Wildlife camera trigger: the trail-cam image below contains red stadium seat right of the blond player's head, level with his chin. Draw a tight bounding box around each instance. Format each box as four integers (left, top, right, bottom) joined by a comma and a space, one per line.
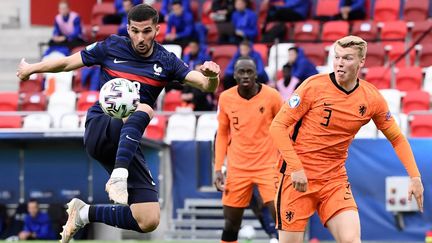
396, 67, 423, 91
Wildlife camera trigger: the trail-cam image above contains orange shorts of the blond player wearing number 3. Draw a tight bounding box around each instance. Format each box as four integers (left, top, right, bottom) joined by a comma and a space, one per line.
275, 175, 357, 232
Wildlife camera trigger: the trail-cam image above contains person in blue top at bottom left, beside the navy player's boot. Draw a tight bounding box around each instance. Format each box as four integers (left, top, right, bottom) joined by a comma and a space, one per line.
18, 199, 56, 240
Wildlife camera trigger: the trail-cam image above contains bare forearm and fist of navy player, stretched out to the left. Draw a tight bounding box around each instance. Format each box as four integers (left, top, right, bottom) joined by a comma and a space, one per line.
16, 52, 84, 80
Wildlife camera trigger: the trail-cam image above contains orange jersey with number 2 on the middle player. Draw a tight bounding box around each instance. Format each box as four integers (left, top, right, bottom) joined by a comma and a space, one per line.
215, 84, 283, 171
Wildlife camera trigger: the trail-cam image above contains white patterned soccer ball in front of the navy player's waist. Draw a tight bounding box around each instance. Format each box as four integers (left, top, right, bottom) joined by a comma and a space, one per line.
99, 78, 140, 119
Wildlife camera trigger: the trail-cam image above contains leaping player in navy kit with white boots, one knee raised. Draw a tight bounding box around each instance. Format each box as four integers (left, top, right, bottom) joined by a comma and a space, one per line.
17, 4, 220, 243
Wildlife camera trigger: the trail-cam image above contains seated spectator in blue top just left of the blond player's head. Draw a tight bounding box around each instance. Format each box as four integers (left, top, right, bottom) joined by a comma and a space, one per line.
287, 47, 318, 91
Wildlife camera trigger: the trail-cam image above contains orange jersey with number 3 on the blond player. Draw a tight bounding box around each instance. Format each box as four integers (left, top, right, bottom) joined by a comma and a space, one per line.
272, 73, 395, 179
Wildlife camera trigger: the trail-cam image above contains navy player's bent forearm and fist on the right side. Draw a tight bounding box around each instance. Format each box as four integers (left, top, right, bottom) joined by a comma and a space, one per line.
185, 61, 220, 92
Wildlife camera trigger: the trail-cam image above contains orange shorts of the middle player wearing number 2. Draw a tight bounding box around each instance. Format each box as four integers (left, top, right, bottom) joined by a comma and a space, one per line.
222, 168, 277, 208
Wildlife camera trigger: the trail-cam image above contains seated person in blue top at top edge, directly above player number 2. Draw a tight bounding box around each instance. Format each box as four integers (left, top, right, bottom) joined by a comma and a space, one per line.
218, 0, 258, 44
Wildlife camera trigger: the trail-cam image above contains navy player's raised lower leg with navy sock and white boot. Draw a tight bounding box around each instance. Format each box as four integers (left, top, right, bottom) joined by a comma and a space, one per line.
105, 104, 154, 205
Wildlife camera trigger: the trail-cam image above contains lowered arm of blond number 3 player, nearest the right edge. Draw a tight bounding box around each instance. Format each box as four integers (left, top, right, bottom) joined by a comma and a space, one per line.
382, 122, 424, 212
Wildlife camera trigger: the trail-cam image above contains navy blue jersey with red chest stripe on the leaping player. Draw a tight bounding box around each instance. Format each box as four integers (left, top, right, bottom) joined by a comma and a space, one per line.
81, 35, 190, 106
